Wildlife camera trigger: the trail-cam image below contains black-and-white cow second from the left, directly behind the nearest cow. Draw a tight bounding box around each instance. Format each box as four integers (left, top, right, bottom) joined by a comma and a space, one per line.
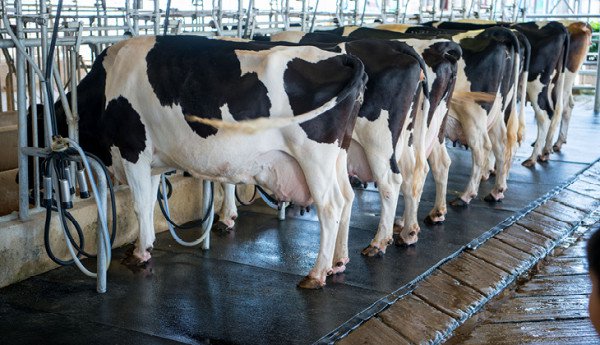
218, 33, 438, 251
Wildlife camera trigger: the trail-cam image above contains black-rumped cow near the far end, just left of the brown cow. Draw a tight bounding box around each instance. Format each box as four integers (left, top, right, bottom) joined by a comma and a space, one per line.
420, 21, 568, 167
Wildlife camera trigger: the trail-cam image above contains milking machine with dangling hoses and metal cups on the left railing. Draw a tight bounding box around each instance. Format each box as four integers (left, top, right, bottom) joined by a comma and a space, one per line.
11, 0, 116, 292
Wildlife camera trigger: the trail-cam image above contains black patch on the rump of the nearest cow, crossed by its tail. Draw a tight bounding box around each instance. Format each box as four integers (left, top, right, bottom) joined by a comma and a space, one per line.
283, 55, 363, 147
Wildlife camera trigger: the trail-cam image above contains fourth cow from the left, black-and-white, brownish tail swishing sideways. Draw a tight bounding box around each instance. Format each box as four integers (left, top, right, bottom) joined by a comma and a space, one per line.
322, 27, 520, 210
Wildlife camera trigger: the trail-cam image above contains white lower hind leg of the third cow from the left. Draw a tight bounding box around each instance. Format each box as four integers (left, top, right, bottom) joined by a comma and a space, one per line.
425, 142, 451, 224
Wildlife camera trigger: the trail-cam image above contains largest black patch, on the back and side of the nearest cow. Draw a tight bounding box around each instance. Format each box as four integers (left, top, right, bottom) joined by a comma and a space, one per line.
146, 35, 271, 138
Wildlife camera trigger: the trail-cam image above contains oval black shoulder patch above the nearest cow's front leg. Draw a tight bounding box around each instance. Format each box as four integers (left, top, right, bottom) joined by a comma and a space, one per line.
102, 96, 146, 163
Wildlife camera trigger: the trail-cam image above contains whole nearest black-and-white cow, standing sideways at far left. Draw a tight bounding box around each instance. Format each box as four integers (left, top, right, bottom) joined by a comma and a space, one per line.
45, 36, 366, 288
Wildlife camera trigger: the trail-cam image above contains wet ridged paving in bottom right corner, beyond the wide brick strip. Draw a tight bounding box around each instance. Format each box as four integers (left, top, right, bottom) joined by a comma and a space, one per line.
447, 219, 600, 345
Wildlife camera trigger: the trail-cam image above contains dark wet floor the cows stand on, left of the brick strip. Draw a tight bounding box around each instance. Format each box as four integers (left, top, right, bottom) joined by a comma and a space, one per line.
0, 98, 600, 344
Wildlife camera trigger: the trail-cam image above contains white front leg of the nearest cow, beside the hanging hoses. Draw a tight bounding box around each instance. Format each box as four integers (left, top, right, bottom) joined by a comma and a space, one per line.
123, 159, 160, 265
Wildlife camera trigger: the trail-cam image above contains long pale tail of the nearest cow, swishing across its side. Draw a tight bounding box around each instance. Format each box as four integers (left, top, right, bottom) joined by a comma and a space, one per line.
185, 55, 367, 134
